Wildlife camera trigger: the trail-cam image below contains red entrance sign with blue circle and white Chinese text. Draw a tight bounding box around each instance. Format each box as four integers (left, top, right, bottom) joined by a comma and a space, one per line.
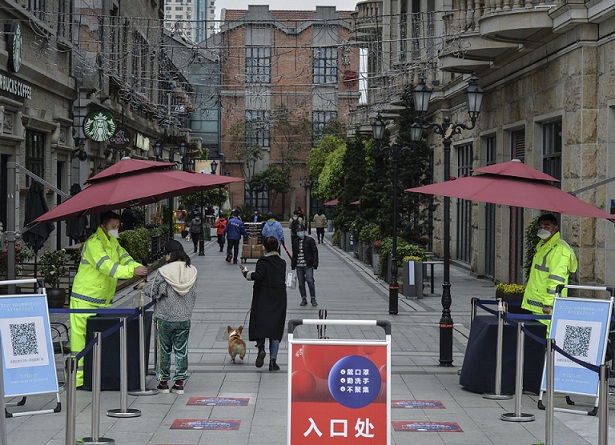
289, 344, 389, 445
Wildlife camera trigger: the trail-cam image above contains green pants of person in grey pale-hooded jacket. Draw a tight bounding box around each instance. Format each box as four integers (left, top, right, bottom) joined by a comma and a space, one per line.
156, 319, 190, 382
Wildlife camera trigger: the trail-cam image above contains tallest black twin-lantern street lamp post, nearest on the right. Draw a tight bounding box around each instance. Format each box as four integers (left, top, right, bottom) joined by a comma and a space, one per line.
410, 75, 484, 366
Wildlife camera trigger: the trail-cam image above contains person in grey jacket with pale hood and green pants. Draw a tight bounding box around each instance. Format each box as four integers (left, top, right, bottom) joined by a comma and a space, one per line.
138, 239, 197, 394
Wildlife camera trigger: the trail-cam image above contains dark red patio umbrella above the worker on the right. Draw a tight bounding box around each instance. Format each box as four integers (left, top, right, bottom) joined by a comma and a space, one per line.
405, 161, 615, 219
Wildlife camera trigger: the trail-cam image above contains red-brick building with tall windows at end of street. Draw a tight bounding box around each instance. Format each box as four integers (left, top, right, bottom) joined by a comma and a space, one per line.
220, 5, 359, 216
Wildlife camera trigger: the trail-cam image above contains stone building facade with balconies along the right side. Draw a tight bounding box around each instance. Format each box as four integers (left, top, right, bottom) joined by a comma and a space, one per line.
355, 0, 615, 284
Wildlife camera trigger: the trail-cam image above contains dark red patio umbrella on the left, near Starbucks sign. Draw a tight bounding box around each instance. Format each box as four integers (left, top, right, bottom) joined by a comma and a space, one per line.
33, 161, 243, 223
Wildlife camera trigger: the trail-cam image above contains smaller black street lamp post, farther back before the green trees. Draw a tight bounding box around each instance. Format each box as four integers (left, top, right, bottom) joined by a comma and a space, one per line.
372, 114, 407, 315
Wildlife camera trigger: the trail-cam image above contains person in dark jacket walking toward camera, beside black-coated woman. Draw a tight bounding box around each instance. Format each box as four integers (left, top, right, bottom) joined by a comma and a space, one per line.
291, 225, 318, 306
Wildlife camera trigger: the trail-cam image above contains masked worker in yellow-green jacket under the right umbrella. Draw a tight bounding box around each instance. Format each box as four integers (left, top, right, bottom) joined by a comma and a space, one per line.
521, 214, 578, 336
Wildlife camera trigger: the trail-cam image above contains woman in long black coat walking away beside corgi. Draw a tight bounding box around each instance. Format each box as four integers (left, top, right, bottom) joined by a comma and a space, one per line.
240, 237, 287, 371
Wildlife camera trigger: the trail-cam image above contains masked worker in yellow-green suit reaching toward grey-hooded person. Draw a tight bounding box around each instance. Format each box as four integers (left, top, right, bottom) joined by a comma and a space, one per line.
70, 212, 147, 387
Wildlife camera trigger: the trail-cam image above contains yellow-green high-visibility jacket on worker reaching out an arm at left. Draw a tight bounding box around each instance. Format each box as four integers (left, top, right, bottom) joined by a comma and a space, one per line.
70, 227, 141, 306
